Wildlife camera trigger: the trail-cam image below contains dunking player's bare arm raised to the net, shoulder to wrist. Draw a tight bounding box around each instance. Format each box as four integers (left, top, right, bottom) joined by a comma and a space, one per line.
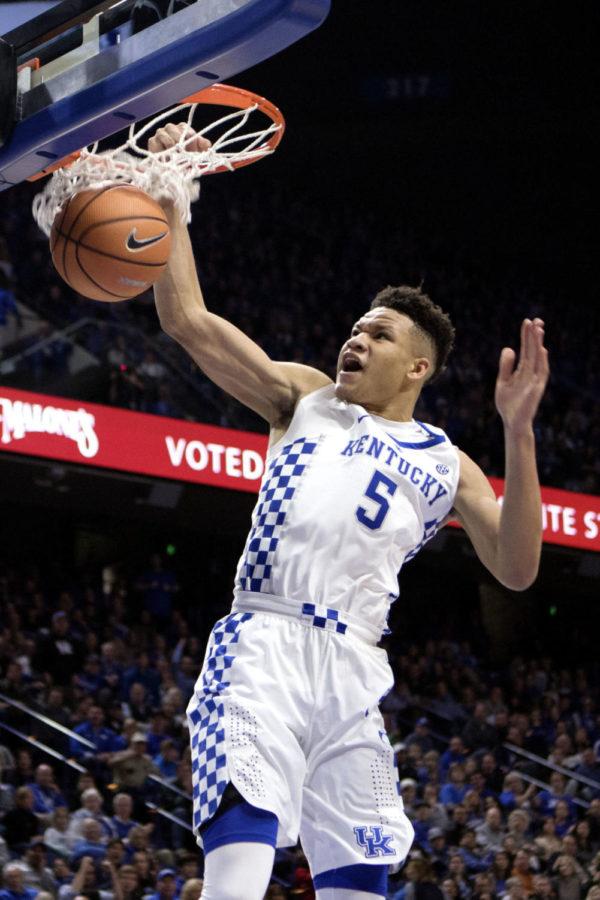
154, 199, 329, 426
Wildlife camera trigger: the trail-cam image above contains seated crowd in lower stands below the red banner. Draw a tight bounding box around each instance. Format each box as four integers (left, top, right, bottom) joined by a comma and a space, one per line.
0, 555, 600, 900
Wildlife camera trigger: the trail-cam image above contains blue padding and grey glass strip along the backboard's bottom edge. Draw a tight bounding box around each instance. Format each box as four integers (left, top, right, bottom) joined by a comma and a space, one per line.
0, 0, 330, 190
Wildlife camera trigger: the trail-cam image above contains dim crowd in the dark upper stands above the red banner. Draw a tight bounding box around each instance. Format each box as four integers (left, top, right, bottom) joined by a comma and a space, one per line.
0, 183, 600, 493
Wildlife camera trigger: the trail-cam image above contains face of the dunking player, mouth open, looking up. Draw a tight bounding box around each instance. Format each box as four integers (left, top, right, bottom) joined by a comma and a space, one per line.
335, 306, 431, 414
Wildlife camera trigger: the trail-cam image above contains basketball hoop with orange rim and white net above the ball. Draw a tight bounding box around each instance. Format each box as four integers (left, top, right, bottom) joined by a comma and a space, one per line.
31, 84, 285, 235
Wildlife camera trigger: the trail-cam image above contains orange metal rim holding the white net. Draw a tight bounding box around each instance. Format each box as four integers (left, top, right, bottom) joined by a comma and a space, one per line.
27, 82, 285, 181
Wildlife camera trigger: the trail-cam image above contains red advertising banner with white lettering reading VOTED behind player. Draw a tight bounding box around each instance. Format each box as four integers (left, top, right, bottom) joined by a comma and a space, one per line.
0, 387, 600, 551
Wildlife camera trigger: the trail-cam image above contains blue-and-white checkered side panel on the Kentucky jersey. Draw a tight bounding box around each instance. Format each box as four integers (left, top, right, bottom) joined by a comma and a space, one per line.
238, 438, 317, 594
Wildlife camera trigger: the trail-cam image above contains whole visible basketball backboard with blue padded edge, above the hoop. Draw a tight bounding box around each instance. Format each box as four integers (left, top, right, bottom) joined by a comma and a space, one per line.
0, 0, 330, 190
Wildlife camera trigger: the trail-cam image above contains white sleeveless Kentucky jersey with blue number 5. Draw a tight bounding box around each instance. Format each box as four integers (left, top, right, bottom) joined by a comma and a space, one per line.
235, 385, 459, 631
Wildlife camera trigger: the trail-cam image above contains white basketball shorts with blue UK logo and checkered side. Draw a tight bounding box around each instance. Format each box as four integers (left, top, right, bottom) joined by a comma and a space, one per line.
187, 595, 414, 876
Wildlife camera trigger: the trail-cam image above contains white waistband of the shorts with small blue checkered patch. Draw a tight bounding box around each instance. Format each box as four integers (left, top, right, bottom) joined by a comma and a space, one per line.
232, 591, 381, 644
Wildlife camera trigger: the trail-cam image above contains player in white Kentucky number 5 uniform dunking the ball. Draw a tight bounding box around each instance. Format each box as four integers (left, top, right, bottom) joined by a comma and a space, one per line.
149, 124, 548, 900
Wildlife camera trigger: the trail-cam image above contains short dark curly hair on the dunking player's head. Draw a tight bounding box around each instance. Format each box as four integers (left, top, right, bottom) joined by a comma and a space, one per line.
371, 284, 455, 382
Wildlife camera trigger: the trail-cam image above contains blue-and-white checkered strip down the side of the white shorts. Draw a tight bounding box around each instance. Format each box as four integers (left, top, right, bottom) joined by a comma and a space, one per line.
188, 613, 252, 829
